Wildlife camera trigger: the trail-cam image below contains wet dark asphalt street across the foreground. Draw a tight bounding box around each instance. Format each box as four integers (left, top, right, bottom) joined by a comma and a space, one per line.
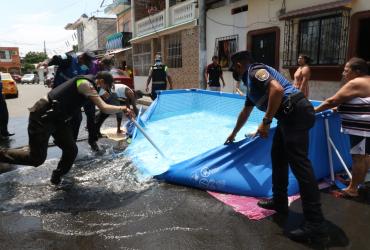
0, 114, 370, 249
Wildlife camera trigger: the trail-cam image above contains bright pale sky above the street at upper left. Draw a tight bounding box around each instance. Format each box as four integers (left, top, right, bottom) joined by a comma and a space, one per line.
0, 0, 114, 56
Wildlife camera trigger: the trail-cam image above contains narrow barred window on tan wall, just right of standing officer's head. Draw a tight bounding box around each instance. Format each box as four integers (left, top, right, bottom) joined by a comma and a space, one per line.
166, 32, 182, 68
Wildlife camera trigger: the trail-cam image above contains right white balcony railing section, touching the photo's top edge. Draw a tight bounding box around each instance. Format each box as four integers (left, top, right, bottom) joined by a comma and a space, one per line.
170, 0, 196, 25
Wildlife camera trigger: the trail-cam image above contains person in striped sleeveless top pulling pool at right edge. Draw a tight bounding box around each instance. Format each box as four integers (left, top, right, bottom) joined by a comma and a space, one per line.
315, 57, 370, 197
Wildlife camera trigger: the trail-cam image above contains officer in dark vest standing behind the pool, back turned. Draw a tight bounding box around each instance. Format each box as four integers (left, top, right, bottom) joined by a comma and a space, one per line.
146, 54, 172, 100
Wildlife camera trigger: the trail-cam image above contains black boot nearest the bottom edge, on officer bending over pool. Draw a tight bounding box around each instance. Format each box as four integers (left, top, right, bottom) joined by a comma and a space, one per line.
288, 221, 329, 244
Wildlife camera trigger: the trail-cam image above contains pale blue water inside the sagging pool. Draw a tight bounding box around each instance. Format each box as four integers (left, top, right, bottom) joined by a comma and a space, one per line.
127, 111, 260, 175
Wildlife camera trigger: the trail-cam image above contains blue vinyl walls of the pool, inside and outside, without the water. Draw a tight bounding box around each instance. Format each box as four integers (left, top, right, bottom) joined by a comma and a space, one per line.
130, 89, 351, 197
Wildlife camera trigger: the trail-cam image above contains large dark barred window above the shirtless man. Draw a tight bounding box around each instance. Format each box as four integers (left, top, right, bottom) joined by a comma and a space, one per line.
283, 11, 349, 66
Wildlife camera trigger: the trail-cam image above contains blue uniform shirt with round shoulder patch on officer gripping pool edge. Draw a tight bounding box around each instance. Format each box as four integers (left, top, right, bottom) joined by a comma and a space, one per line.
242, 63, 299, 111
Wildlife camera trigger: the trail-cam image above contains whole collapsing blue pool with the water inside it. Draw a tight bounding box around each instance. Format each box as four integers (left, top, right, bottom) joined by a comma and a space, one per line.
127, 89, 351, 197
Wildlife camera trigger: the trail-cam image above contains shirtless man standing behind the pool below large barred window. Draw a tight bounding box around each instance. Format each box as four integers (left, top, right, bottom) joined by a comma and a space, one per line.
293, 54, 311, 98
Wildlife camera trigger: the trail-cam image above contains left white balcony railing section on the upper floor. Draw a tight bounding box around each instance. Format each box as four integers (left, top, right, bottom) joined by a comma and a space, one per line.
136, 11, 165, 36
